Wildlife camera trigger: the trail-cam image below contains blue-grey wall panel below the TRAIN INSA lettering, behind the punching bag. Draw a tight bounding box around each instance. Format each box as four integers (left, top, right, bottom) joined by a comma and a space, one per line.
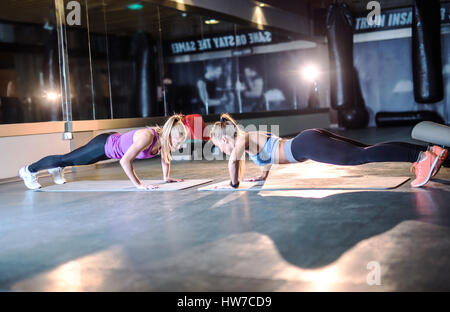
354, 34, 450, 126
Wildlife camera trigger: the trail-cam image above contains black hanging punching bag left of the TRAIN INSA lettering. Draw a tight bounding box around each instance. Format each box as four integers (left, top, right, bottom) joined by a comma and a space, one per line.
326, 3, 353, 109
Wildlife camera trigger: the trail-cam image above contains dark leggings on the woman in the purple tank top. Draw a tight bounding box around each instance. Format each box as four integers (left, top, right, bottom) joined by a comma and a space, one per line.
28, 133, 113, 172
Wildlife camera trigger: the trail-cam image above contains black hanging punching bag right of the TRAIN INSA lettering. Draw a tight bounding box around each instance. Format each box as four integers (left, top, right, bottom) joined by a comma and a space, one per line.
411, 0, 444, 103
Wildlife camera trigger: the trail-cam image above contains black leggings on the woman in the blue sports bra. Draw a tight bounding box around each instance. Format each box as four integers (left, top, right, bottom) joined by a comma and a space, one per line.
291, 129, 427, 165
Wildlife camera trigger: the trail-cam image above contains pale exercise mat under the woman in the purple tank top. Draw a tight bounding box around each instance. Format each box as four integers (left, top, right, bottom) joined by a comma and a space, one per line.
37, 179, 212, 192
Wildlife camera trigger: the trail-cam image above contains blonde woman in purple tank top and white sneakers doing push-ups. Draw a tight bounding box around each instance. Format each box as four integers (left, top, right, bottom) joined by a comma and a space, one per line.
19, 115, 188, 189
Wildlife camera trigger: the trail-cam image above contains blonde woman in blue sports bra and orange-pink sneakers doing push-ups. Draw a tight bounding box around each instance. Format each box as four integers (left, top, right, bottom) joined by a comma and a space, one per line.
210, 114, 450, 188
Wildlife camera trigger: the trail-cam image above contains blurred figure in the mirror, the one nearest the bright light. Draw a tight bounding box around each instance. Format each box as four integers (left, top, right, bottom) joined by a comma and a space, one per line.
236, 64, 264, 112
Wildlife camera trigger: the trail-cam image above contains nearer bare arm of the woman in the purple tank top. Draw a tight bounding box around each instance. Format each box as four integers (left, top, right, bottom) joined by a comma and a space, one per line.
120, 131, 155, 189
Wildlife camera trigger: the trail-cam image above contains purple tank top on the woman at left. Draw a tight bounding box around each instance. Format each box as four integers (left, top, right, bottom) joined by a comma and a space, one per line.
105, 128, 158, 159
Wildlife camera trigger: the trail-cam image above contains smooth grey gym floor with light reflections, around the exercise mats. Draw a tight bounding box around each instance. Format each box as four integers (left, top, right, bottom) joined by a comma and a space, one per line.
0, 128, 450, 291
